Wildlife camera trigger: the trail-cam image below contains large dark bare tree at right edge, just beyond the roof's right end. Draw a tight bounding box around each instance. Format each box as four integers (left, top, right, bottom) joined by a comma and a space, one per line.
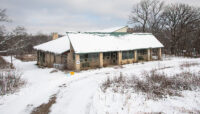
162, 4, 200, 54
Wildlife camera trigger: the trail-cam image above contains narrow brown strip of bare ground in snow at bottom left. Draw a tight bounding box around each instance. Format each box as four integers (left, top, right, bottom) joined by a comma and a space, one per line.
31, 95, 57, 114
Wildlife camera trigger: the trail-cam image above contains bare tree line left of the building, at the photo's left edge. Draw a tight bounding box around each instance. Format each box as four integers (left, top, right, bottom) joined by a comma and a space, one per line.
0, 9, 52, 55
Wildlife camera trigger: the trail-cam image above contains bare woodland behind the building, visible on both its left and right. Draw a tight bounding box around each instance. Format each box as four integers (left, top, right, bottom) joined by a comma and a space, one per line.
0, 0, 200, 55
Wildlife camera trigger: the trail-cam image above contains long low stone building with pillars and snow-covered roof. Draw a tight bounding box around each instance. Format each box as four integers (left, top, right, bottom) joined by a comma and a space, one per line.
34, 32, 164, 71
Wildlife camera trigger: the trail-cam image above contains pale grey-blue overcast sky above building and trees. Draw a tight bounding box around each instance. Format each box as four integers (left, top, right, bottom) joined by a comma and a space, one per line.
0, 0, 200, 33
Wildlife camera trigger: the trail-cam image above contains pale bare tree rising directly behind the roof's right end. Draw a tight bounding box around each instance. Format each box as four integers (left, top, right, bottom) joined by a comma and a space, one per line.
129, 0, 164, 32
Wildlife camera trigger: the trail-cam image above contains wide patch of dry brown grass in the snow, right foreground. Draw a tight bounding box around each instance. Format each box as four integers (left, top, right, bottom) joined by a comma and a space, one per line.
101, 70, 200, 99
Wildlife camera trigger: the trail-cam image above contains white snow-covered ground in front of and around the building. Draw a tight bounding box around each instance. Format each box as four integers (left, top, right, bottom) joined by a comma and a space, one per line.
0, 57, 200, 114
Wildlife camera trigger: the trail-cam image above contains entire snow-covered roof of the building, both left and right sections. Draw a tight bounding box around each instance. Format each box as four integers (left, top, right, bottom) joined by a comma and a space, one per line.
34, 32, 164, 54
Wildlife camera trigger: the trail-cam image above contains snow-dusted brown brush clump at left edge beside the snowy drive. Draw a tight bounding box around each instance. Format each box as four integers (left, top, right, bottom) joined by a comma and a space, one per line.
0, 69, 25, 95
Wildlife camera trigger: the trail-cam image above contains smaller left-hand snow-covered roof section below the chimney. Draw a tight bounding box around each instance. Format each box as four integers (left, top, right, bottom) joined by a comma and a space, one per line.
34, 35, 70, 54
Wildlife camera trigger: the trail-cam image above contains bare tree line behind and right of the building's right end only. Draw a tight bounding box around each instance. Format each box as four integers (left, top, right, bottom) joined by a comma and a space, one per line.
128, 0, 200, 55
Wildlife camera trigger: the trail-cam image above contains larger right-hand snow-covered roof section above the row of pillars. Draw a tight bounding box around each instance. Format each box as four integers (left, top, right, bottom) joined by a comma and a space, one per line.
68, 33, 164, 53
